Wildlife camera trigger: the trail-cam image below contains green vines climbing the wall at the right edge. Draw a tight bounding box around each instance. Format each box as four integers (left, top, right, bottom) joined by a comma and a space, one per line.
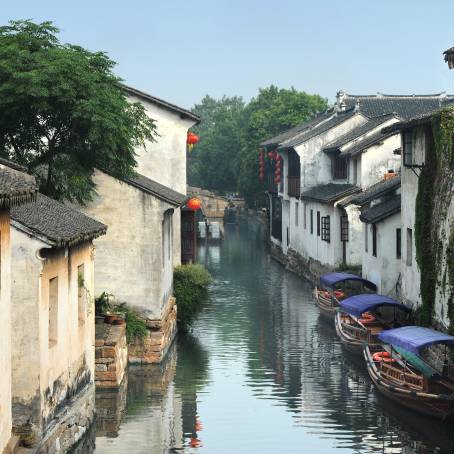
415, 107, 454, 333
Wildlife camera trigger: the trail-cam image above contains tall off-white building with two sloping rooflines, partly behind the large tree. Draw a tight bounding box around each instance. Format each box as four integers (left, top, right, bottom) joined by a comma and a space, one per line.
81, 86, 199, 363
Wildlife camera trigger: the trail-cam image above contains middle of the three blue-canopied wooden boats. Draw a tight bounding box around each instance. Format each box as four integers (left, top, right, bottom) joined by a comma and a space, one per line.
334, 293, 411, 355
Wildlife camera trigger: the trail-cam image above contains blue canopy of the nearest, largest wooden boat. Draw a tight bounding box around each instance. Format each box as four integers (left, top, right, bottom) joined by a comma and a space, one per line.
378, 326, 454, 355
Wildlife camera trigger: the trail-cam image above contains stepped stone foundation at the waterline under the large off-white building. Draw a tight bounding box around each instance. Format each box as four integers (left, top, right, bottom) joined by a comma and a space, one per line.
129, 297, 177, 364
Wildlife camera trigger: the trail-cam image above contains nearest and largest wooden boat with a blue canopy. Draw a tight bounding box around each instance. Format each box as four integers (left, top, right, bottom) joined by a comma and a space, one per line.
363, 326, 454, 419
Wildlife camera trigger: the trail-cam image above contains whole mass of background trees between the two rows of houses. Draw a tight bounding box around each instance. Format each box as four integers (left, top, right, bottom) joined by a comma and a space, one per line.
189, 85, 327, 206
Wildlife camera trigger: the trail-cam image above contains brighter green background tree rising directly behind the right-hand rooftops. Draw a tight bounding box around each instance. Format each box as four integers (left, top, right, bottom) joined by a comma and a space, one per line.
238, 85, 328, 206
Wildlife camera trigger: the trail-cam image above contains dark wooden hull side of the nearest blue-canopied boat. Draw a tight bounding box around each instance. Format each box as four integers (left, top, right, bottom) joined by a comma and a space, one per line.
363, 346, 454, 420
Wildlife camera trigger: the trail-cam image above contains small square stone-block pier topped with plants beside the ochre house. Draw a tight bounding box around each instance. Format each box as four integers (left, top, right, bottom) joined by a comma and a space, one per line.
95, 323, 128, 388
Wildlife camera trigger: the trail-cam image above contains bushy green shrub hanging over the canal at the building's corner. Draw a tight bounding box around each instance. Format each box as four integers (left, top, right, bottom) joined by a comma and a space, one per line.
173, 264, 211, 331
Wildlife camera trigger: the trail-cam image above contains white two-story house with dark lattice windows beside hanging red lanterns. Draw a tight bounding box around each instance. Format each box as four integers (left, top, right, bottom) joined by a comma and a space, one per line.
262, 92, 452, 278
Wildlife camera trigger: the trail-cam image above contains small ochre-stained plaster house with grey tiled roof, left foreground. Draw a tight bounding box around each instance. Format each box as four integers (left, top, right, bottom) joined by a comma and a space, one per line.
11, 194, 106, 452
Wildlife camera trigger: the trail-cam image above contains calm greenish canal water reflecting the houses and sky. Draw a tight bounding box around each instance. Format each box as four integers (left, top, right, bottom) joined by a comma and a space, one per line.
92, 221, 454, 454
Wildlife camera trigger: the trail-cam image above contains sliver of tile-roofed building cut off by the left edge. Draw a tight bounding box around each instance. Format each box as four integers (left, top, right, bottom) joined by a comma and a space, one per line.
0, 165, 37, 453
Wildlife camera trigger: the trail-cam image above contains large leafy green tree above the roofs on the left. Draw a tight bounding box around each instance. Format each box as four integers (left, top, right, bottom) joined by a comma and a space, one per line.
0, 20, 156, 203
